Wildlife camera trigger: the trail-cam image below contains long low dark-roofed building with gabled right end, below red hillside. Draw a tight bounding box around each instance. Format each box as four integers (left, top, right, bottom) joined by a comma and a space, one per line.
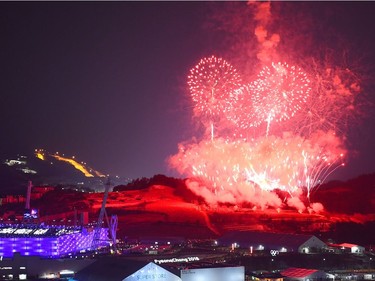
218, 231, 327, 255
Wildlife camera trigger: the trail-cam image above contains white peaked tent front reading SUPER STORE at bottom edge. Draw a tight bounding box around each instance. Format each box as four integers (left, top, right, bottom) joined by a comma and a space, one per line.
122, 262, 181, 281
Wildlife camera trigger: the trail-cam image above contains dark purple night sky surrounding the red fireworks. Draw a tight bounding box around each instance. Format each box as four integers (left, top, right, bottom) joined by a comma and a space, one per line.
0, 2, 375, 178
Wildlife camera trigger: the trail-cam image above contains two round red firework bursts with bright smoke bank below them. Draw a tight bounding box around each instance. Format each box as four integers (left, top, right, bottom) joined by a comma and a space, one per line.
170, 54, 358, 212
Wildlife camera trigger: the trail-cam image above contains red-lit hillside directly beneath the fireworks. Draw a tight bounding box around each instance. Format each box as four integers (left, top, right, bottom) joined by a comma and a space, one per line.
5, 175, 368, 244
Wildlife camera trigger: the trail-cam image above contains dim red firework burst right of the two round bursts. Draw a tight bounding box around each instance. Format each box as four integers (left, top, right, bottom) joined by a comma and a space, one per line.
285, 65, 363, 137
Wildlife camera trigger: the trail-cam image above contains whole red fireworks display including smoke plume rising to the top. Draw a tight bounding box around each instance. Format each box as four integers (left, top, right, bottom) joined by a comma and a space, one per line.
170, 2, 361, 213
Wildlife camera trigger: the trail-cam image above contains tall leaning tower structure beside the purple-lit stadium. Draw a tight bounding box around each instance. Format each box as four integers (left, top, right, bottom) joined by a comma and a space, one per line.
91, 178, 117, 252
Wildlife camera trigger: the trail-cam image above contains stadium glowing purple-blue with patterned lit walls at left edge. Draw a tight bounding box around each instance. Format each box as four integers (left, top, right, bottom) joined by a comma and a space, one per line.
0, 224, 109, 258
